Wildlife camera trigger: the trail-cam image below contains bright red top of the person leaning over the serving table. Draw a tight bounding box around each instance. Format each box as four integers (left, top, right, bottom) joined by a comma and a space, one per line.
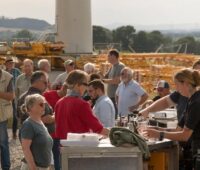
55, 96, 103, 139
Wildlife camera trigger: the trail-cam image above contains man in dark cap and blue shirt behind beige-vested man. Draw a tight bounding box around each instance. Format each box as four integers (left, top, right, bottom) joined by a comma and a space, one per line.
5, 57, 21, 139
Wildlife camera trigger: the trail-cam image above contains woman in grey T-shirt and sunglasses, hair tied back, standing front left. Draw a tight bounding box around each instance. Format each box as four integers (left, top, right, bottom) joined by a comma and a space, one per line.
20, 94, 53, 170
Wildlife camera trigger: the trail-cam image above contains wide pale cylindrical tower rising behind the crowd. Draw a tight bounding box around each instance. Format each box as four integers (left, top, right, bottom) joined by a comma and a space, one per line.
56, 0, 93, 54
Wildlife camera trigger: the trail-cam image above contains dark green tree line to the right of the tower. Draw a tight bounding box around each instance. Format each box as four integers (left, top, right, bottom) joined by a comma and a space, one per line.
93, 25, 200, 54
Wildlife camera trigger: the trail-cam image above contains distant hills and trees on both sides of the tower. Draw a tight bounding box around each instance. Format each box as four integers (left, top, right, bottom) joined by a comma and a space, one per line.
0, 17, 200, 54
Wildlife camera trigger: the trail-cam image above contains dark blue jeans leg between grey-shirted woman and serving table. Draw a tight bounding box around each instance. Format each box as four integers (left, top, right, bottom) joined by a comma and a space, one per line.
52, 139, 61, 170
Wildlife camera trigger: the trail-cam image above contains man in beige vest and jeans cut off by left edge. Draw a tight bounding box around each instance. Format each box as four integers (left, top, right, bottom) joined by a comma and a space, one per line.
0, 69, 15, 170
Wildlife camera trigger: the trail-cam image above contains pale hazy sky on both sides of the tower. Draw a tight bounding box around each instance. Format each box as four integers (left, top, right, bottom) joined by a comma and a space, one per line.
0, 0, 200, 26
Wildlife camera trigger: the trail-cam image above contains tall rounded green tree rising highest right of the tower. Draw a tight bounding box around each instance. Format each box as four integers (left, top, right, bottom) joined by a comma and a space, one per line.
113, 25, 136, 50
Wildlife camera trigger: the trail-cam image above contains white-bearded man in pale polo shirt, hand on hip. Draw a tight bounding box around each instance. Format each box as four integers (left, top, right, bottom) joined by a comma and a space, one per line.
116, 67, 148, 116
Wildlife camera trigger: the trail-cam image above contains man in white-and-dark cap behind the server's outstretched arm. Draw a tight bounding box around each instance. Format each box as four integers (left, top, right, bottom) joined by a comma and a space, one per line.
152, 80, 170, 102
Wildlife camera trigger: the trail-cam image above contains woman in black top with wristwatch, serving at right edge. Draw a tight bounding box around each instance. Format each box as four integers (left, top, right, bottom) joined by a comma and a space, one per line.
147, 69, 200, 169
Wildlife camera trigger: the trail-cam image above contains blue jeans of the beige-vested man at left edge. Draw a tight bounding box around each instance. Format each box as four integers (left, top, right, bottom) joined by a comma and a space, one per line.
0, 121, 10, 170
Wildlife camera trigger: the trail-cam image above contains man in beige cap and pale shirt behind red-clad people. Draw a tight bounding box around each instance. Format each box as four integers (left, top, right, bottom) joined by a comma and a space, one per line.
51, 59, 75, 90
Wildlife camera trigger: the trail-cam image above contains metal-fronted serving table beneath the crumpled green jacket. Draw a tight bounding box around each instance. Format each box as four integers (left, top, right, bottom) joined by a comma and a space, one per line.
61, 140, 178, 170
